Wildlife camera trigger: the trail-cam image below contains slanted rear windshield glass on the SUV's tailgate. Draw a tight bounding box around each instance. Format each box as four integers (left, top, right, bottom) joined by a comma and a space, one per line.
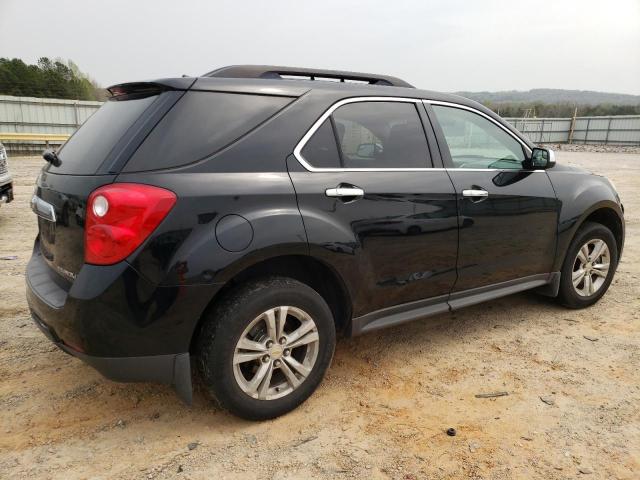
54, 95, 158, 175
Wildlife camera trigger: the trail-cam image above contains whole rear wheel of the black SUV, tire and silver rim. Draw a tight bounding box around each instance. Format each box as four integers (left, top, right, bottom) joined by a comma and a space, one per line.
197, 277, 336, 420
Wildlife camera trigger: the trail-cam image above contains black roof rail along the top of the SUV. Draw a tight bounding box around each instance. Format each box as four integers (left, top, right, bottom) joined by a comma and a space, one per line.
203, 65, 414, 88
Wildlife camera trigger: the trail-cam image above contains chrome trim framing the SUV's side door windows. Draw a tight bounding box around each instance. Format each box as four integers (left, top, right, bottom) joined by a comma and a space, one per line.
293, 97, 544, 173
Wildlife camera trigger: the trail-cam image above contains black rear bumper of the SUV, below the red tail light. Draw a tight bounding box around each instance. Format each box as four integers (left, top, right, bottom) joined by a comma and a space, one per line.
26, 241, 222, 403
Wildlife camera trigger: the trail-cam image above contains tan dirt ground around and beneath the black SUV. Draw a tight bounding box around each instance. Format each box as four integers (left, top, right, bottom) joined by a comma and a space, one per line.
0, 151, 640, 479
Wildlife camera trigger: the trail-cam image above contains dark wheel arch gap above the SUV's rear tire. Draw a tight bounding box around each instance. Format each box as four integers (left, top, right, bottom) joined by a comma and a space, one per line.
189, 254, 352, 352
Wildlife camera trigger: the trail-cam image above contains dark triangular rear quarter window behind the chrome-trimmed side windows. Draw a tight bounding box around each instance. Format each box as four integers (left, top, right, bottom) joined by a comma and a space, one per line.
124, 91, 292, 172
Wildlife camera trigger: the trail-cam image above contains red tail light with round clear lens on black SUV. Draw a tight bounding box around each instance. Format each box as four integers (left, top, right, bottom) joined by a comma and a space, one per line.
84, 183, 176, 265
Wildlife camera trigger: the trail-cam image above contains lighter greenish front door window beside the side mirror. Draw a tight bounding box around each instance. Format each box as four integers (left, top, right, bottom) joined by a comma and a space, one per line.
433, 105, 525, 169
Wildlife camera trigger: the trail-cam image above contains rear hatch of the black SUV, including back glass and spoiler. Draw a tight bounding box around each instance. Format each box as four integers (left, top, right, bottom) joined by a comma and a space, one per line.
32, 79, 193, 282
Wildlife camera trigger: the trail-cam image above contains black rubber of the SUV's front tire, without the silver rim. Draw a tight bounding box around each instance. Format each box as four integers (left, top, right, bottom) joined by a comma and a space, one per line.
558, 222, 618, 308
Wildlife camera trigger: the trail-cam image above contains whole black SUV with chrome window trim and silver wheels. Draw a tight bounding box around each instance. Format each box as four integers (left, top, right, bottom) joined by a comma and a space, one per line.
27, 66, 624, 419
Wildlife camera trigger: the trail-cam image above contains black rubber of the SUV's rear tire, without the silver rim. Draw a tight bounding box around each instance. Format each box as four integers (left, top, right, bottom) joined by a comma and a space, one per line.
198, 278, 336, 420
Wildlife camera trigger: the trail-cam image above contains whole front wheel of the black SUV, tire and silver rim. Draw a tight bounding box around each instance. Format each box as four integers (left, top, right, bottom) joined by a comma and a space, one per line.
558, 222, 618, 308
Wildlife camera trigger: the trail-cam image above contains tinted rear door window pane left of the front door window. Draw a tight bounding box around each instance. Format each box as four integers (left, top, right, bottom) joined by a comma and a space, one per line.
333, 102, 431, 168
